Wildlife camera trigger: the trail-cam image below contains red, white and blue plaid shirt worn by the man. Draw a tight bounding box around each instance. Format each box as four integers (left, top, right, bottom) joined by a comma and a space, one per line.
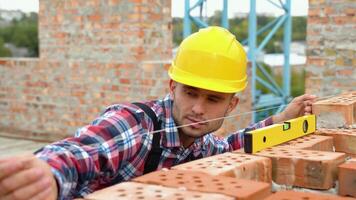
36, 95, 272, 199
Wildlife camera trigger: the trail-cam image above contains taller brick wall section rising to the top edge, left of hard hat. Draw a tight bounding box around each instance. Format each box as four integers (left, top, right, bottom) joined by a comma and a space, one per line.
39, 0, 172, 63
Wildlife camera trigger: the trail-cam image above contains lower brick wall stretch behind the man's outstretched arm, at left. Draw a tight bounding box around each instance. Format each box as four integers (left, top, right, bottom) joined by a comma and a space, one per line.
0, 59, 168, 140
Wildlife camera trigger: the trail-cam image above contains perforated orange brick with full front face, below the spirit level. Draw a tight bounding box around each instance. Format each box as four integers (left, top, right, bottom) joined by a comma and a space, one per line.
257, 147, 346, 189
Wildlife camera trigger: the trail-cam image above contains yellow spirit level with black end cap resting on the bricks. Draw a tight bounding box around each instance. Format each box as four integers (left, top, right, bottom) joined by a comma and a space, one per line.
244, 115, 316, 153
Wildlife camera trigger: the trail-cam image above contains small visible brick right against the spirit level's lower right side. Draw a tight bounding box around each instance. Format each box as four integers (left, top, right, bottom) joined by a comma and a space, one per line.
277, 134, 334, 151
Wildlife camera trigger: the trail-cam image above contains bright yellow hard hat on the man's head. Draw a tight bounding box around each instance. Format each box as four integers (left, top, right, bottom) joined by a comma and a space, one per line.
168, 26, 247, 93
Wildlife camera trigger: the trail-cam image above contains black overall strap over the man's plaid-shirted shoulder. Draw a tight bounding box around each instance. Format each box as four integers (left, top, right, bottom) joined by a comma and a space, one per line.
132, 102, 162, 174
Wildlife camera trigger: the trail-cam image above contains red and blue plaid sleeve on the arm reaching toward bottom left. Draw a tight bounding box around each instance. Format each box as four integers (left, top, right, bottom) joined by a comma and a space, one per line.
36, 109, 149, 199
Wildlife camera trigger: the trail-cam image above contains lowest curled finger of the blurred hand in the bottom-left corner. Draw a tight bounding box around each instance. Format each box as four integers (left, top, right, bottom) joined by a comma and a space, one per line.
4, 177, 51, 200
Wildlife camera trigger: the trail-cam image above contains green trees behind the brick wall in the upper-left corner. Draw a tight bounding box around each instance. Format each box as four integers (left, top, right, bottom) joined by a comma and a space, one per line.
0, 12, 38, 57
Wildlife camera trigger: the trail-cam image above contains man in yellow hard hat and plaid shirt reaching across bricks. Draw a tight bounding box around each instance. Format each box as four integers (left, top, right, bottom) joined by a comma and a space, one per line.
0, 27, 315, 200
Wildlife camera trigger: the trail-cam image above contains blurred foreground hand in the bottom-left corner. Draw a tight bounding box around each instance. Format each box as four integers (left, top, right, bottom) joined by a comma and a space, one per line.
0, 155, 58, 200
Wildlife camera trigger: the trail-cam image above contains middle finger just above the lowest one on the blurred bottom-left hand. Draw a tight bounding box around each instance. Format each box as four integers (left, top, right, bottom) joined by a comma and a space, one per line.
0, 168, 44, 196
